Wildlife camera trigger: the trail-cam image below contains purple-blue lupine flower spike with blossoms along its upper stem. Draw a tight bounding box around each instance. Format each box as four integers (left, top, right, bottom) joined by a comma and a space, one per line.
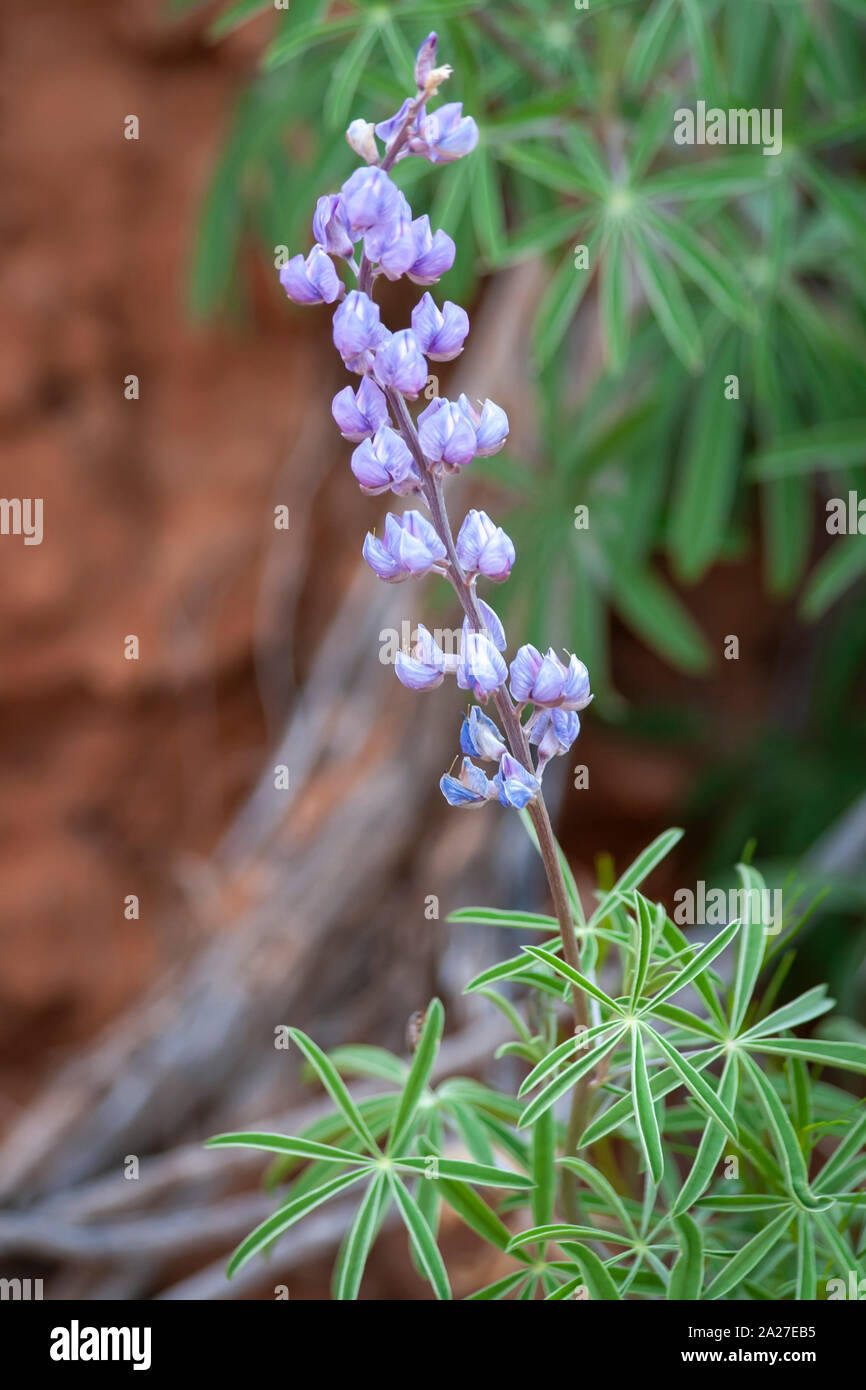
279, 33, 592, 809
